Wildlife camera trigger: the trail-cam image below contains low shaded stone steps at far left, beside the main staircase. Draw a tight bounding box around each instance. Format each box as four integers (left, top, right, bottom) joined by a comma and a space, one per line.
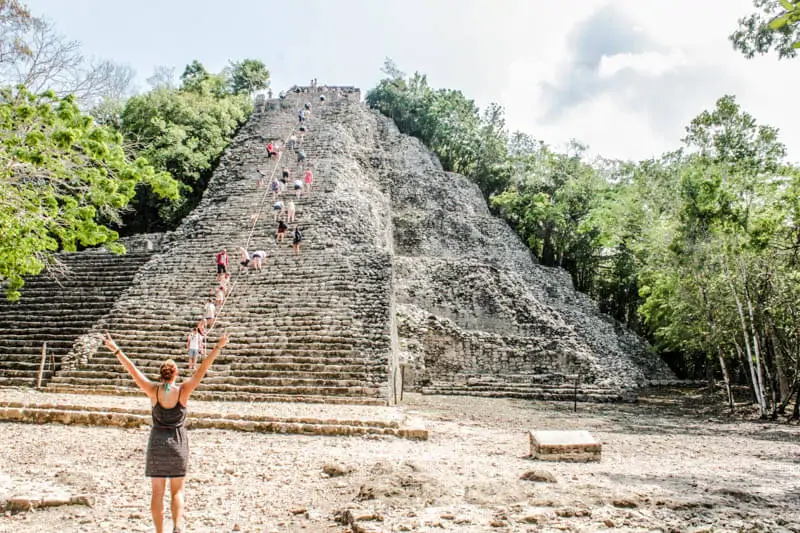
0, 251, 152, 387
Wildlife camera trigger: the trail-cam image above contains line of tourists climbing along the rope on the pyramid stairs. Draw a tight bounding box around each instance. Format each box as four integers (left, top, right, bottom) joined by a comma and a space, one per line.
186, 87, 327, 370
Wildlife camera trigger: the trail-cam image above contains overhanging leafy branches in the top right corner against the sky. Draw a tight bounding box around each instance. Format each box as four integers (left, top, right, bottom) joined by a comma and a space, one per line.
728, 0, 800, 59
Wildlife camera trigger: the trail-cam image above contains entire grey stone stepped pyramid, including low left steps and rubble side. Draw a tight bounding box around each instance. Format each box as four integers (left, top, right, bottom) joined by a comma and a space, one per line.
0, 87, 671, 405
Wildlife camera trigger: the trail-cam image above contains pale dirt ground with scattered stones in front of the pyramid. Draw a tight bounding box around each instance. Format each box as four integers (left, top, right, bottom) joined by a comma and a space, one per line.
0, 388, 800, 533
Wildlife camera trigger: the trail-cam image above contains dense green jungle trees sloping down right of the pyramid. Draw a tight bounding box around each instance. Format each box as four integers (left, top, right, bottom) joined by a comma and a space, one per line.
366, 60, 800, 416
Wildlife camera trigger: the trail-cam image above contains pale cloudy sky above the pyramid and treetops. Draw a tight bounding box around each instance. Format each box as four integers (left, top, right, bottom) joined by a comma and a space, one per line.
26, 0, 800, 161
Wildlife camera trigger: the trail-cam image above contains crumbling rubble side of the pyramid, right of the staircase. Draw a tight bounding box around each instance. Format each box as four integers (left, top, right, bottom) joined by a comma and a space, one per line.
322, 100, 670, 390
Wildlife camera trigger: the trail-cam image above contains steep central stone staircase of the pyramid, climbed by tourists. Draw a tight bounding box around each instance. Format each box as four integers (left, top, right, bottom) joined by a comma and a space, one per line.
47, 87, 391, 404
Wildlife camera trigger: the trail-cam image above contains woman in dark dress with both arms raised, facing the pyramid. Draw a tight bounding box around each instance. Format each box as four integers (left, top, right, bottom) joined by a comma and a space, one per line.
103, 332, 230, 533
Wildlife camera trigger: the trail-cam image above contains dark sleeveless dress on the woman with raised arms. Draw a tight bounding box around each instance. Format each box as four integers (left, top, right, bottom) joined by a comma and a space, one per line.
144, 385, 189, 477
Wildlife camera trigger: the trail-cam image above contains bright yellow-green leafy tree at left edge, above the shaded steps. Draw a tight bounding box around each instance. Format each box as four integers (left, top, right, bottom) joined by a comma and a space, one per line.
0, 87, 178, 299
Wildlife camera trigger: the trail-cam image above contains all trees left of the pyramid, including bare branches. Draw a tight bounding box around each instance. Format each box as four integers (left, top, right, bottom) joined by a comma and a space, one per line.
0, 0, 269, 299
